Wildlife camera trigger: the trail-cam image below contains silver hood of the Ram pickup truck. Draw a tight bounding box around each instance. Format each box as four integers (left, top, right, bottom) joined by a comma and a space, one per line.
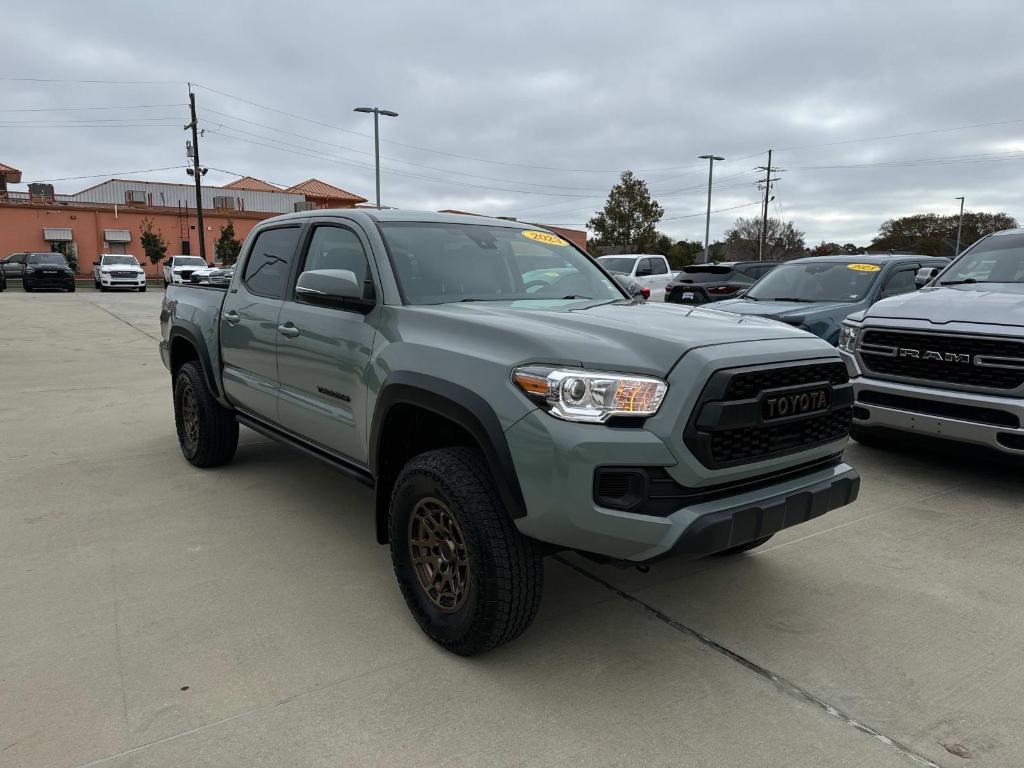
865, 283, 1024, 327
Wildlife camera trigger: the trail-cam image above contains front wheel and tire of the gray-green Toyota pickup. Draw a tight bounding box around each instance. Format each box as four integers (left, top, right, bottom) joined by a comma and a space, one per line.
390, 447, 544, 656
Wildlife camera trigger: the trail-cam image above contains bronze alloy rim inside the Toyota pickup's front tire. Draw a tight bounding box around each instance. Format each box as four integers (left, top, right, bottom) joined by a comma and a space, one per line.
409, 497, 469, 613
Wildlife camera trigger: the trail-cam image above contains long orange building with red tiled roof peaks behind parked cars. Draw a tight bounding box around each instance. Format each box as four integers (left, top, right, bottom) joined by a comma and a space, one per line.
0, 163, 587, 276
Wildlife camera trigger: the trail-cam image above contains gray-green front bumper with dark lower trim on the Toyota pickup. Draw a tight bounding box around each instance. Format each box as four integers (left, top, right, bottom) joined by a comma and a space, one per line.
505, 411, 859, 563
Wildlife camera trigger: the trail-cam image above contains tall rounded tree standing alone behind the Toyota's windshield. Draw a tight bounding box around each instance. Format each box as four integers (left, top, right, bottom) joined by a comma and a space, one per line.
587, 171, 665, 253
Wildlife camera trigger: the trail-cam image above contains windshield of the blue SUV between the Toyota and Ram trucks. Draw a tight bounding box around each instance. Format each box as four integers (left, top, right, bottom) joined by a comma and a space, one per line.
746, 261, 882, 301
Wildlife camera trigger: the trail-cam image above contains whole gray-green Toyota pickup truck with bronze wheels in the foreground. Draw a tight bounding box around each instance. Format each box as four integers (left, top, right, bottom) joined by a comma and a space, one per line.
160, 210, 859, 655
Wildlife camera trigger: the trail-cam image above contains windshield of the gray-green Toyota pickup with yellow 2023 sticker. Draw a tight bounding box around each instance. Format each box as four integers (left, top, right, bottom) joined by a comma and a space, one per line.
381, 221, 626, 304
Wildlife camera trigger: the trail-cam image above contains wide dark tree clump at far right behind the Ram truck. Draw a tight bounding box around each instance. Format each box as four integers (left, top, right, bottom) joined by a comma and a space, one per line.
870, 211, 1018, 256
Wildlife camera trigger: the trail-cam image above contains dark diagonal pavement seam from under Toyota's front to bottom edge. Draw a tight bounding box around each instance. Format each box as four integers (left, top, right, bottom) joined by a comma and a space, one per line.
554, 555, 942, 768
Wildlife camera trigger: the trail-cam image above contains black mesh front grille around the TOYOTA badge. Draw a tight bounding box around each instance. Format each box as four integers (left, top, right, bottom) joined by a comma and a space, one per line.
684, 361, 853, 469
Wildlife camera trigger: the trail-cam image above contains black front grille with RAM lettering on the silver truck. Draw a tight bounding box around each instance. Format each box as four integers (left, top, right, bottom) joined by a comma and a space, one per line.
860, 330, 1024, 389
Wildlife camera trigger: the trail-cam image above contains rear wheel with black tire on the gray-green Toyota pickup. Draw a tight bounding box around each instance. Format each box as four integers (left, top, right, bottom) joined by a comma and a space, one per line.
174, 361, 239, 468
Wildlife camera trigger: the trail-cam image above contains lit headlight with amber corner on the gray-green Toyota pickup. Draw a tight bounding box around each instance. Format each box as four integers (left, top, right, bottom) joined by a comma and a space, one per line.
512, 366, 669, 423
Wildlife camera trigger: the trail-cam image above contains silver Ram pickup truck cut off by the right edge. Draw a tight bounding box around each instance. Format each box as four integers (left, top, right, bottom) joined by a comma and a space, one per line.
839, 229, 1024, 457
